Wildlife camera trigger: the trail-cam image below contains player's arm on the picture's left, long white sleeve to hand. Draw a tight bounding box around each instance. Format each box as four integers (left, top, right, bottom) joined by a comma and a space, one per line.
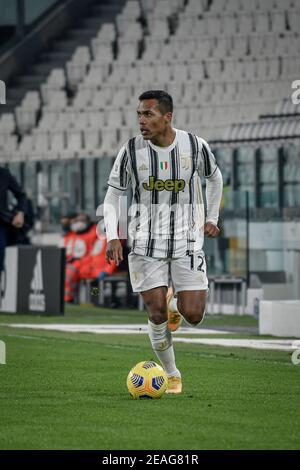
104, 145, 130, 265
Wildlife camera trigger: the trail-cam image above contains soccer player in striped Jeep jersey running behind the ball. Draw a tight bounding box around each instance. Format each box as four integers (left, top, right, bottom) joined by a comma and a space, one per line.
104, 90, 223, 393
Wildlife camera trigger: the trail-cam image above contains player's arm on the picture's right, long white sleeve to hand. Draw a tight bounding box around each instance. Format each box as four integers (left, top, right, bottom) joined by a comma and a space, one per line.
199, 139, 223, 237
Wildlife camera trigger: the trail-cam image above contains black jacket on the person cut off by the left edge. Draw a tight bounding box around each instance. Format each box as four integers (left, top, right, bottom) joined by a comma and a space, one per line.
0, 167, 27, 224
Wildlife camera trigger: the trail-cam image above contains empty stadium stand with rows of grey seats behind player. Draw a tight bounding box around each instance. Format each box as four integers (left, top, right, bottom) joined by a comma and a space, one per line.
0, 0, 300, 224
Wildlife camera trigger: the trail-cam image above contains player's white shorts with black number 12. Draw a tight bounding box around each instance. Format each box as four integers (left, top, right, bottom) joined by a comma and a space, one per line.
128, 250, 208, 294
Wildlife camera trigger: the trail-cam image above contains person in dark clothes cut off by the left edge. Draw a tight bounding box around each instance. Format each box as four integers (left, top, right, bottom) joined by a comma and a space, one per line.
0, 167, 27, 275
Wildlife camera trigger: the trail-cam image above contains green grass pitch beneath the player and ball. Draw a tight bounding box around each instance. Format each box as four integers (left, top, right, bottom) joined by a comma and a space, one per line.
0, 307, 300, 450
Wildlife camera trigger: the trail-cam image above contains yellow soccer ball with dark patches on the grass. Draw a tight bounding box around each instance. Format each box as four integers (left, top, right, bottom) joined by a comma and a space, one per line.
127, 361, 168, 399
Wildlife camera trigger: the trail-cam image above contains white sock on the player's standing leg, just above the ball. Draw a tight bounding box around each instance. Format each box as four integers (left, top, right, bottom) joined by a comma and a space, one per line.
148, 320, 181, 377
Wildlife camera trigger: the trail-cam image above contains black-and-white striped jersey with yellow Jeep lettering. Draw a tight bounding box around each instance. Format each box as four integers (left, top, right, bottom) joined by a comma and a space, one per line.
108, 129, 217, 258
